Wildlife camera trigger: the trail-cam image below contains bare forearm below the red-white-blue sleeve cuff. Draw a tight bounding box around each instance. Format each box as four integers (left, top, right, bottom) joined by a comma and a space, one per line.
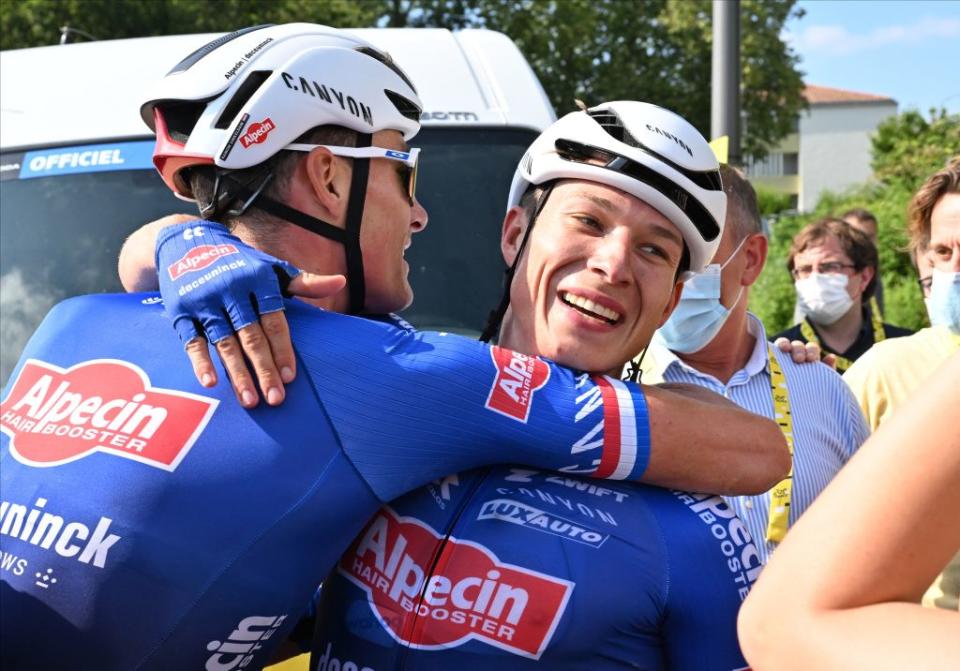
641, 383, 790, 495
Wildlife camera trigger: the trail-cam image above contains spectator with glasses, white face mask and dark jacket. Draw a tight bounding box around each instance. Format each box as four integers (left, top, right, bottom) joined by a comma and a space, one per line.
776, 218, 911, 373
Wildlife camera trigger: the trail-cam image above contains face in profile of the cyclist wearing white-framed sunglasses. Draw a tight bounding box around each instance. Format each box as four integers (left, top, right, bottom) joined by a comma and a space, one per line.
360, 131, 427, 313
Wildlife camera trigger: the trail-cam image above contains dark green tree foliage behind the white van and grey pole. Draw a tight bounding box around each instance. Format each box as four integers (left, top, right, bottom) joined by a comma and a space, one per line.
0, 0, 804, 156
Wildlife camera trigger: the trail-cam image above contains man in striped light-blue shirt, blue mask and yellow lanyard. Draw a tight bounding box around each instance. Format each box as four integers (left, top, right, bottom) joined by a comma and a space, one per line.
638, 166, 868, 560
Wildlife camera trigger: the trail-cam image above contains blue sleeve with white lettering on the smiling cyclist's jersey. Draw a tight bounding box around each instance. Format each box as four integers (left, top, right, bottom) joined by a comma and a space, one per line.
657, 492, 761, 671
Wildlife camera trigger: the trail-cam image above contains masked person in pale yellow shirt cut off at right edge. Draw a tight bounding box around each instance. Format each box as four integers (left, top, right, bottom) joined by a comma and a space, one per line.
843, 159, 960, 610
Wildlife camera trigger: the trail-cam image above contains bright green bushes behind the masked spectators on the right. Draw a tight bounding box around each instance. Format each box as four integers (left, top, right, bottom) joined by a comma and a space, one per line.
750, 110, 960, 333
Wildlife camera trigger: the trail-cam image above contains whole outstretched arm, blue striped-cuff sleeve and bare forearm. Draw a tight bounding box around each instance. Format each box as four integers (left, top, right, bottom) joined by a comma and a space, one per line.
287, 302, 787, 501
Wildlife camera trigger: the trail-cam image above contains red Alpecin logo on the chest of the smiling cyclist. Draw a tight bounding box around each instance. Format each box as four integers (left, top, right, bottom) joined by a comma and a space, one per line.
338, 508, 574, 659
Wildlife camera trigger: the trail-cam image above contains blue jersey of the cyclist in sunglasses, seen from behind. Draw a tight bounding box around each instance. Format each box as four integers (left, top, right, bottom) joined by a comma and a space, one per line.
0, 295, 649, 671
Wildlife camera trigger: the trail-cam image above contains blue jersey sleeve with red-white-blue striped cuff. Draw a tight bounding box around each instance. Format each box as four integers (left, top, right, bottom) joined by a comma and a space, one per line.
288, 305, 650, 501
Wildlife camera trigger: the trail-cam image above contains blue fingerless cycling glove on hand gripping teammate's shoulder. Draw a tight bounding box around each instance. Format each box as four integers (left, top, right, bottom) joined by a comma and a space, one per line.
156, 221, 300, 344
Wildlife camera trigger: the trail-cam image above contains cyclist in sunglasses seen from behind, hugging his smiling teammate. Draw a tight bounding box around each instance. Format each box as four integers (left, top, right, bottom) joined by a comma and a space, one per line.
0, 25, 785, 669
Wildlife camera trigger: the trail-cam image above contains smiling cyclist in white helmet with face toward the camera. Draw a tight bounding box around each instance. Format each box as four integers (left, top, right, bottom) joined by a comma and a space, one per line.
312, 101, 761, 671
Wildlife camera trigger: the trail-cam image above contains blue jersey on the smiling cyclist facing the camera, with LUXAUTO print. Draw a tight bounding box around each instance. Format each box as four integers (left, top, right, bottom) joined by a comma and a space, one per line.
312, 467, 761, 671
